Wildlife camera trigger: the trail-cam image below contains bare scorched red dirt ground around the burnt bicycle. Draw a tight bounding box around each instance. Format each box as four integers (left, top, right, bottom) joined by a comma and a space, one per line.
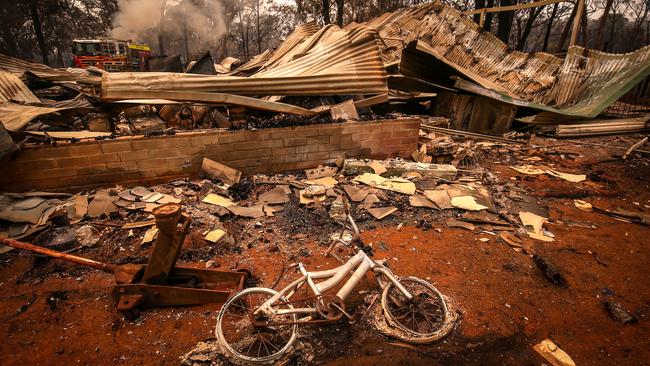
0, 138, 650, 365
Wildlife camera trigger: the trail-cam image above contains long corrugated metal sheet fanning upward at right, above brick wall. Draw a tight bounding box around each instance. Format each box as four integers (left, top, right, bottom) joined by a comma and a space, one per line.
102, 27, 388, 100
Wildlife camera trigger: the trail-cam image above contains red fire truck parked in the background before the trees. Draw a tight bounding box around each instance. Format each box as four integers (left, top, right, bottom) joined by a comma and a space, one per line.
72, 39, 152, 71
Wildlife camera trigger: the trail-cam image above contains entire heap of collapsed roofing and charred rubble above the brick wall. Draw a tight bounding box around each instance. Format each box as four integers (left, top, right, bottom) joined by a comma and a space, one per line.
0, 2, 650, 162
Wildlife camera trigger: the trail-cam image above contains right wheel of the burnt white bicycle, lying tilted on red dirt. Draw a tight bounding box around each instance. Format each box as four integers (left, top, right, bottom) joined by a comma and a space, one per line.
381, 277, 450, 341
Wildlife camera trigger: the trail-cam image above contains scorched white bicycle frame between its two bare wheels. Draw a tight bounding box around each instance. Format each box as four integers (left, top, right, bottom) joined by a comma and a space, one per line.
254, 250, 413, 316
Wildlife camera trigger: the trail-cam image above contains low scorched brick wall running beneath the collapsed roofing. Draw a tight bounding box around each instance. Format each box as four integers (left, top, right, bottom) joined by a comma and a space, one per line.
0, 118, 420, 192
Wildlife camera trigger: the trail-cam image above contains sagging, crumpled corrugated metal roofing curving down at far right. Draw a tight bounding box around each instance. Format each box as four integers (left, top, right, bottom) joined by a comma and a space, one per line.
400, 4, 650, 117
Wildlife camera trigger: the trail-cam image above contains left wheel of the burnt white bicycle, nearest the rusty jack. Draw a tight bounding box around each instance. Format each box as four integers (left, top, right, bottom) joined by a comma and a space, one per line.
215, 287, 298, 363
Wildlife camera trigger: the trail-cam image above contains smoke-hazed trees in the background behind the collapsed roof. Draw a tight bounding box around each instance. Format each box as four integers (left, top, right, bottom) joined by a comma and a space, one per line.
0, 0, 650, 66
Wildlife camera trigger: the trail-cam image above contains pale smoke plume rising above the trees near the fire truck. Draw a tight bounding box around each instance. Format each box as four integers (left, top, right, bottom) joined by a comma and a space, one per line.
109, 0, 226, 55
